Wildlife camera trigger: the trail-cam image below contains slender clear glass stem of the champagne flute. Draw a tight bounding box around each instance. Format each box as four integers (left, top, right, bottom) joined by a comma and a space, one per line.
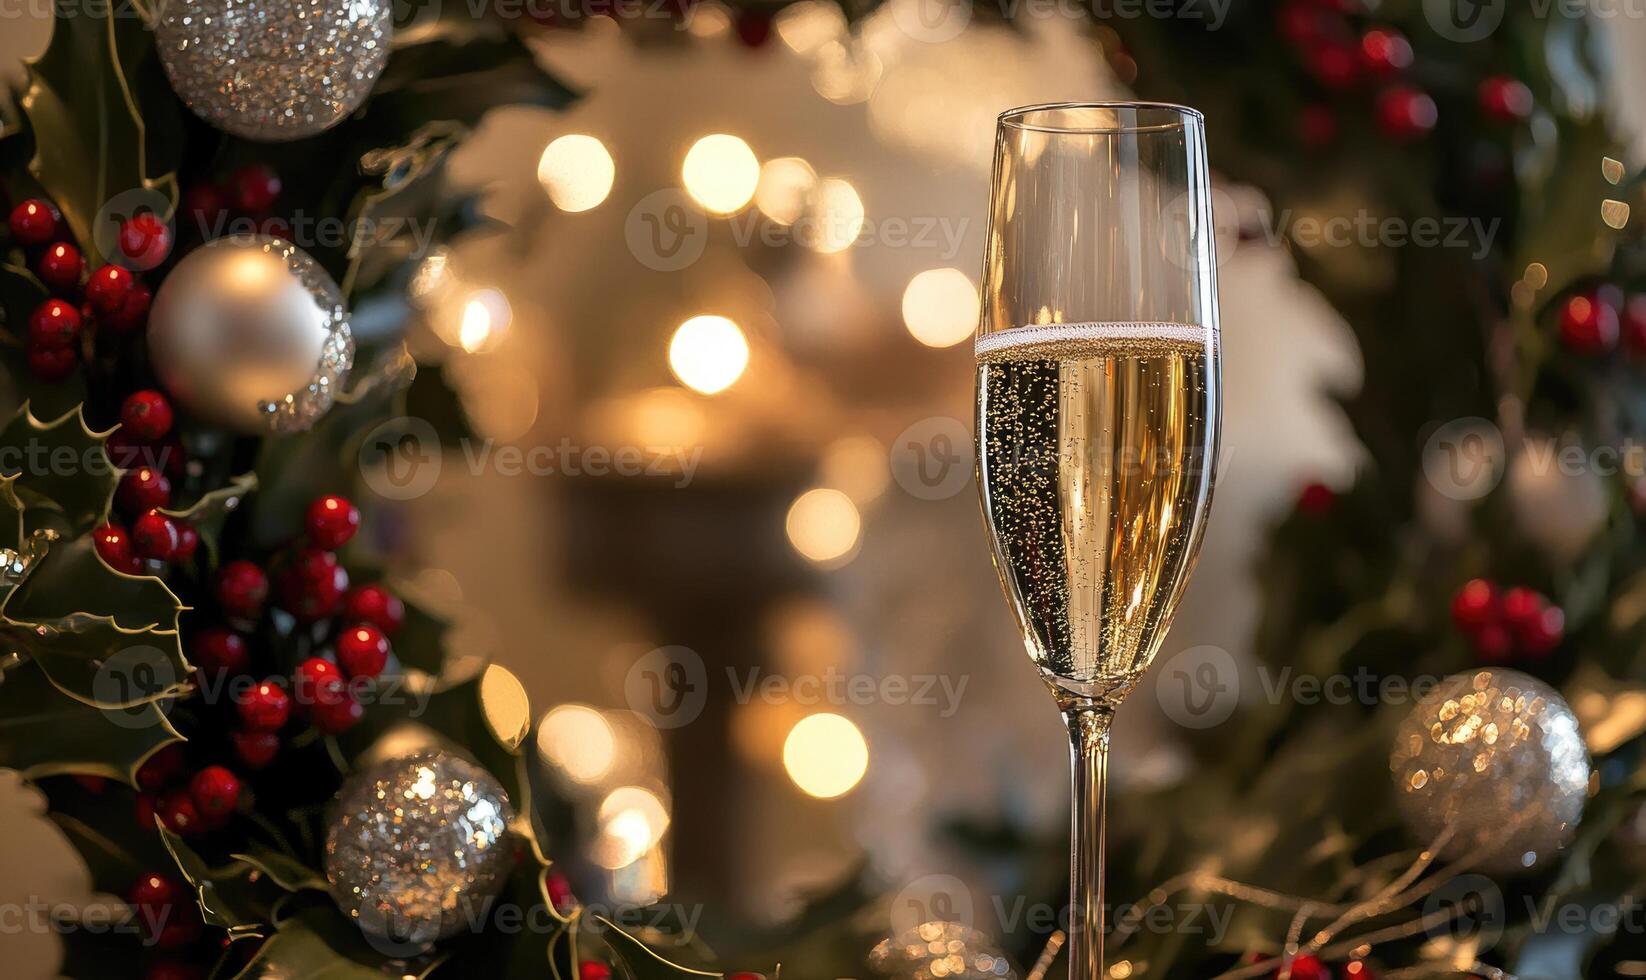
1063, 702, 1114, 980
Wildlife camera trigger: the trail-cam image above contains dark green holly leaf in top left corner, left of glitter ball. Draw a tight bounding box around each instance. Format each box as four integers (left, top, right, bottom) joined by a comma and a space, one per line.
21, 0, 181, 264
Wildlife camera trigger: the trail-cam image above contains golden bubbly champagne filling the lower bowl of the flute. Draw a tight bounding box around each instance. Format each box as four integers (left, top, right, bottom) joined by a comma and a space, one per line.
978, 324, 1221, 700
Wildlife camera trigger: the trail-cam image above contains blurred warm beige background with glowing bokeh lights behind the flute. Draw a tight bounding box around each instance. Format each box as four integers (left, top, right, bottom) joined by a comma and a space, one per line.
0, 0, 1646, 978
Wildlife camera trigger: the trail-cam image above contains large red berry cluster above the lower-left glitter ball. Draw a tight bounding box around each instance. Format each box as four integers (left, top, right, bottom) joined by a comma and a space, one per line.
191, 496, 405, 769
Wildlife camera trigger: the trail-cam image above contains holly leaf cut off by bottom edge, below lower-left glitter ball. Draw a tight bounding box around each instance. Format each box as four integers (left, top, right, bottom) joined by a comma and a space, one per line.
234, 899, 443, 980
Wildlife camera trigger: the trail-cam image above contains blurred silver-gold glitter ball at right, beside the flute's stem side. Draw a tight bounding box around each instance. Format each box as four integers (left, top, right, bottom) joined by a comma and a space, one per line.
1389, 669, 1588, 873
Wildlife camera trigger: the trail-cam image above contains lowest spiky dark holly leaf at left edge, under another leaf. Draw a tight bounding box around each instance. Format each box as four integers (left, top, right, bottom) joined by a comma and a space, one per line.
0, 662, 183, 786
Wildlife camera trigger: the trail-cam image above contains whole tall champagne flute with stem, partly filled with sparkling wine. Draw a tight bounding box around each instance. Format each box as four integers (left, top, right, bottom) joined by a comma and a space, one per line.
976, 102, 1221, 980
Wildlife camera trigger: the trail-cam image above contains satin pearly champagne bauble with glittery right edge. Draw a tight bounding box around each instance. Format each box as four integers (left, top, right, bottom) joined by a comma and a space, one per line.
148, 236, 354, 435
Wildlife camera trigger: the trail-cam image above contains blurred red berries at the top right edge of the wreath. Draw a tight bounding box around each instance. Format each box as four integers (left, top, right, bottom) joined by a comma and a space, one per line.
1277, 0, 1532, 147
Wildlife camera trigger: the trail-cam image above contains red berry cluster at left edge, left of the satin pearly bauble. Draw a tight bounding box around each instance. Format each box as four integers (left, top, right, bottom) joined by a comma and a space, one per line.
10, 198, 161, 380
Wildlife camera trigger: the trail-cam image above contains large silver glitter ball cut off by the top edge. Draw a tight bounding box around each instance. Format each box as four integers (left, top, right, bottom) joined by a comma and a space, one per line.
155, 0, 393, 142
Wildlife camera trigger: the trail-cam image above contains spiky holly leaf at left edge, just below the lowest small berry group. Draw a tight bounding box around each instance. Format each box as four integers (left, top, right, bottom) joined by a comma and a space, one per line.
0, 532, 191, 708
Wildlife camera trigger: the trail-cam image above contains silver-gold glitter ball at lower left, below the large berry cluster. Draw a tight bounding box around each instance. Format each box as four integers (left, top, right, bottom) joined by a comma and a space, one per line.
326, 751, 514, 947
